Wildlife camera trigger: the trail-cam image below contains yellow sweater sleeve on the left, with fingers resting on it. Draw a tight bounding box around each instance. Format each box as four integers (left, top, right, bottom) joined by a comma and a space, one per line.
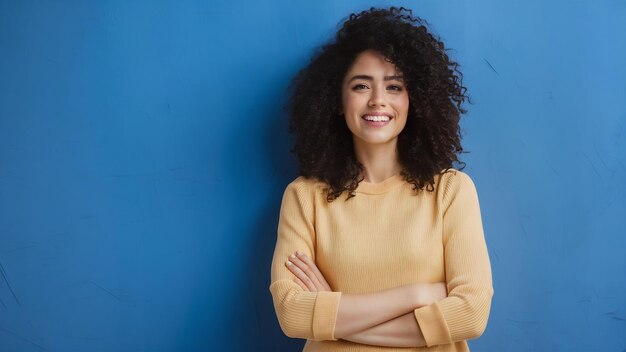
270, 180, 341, 341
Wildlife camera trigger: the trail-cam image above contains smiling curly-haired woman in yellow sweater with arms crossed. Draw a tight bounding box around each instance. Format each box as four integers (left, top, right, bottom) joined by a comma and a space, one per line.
270, 8, 493, 351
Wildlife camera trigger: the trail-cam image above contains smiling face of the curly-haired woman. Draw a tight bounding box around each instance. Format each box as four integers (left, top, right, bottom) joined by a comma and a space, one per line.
342, 50, 409, 147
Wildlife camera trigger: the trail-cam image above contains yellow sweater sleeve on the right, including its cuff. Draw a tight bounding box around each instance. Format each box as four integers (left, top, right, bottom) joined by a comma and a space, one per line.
414, 171, 493, 346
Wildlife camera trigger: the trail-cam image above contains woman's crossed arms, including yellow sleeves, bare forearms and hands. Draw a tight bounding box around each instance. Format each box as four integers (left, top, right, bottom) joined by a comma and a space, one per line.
270, 173, 493, 347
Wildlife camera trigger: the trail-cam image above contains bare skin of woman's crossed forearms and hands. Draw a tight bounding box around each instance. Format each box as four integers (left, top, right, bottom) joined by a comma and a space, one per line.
285, 252, 447, 347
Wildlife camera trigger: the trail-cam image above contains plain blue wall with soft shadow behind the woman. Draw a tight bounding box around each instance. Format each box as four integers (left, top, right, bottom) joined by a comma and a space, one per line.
0, 0, 626, 351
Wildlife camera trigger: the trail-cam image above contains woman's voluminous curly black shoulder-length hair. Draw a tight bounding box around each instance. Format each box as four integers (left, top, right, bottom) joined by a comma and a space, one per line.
286, 7, 468, 202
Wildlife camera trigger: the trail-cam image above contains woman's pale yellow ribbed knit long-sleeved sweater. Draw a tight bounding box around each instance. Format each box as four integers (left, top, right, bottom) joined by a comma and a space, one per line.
270, 170, 493, 352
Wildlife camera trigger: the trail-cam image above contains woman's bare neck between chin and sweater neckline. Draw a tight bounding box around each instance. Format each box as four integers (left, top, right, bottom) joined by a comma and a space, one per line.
354, 141, 402, 183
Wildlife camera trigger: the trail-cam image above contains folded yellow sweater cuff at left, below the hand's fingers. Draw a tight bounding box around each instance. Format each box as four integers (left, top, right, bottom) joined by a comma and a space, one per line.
313, 291, 341, 341
